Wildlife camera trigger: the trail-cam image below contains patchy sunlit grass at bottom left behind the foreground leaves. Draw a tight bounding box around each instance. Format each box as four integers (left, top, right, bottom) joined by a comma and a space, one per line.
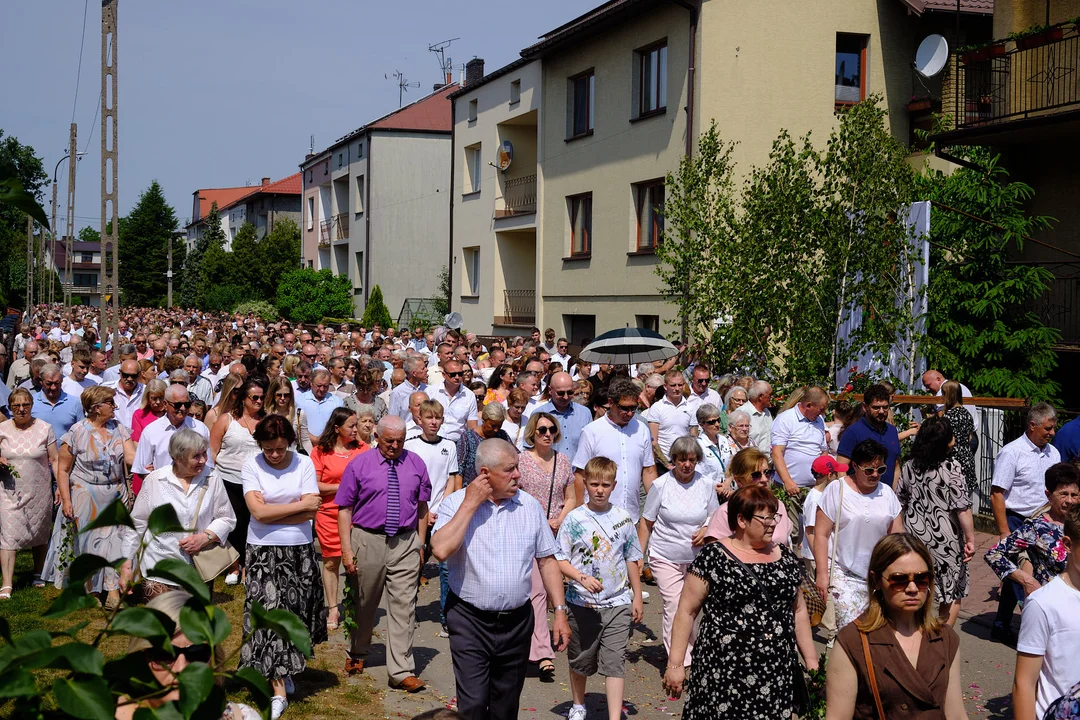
0, 552, 386, 720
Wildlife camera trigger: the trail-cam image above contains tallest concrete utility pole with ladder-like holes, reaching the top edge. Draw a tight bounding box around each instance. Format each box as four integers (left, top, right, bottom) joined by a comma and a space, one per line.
100, 0, 120, 351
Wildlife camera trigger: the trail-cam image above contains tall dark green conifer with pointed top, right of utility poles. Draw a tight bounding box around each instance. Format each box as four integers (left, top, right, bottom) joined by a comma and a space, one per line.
119, 180, 178, 307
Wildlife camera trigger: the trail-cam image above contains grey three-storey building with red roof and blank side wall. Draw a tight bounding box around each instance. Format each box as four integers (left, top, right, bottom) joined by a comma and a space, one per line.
300, 84, 458, 317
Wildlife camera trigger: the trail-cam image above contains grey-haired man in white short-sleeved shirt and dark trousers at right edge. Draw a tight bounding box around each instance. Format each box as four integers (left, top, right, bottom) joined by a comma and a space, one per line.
990, 403, 1061, 642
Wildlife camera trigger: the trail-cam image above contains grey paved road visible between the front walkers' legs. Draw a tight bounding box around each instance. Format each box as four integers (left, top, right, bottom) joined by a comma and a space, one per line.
347, 535, 1018, 720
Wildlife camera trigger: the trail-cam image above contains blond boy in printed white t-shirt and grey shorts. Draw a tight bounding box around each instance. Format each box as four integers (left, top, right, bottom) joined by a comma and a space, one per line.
555, 457, 643, 720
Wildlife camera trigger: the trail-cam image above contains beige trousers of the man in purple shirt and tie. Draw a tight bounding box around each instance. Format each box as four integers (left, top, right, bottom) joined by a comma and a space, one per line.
348, 527, 420, 684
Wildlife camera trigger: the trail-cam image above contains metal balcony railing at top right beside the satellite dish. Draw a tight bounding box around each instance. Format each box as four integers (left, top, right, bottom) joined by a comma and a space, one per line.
954, 23, 1080, 128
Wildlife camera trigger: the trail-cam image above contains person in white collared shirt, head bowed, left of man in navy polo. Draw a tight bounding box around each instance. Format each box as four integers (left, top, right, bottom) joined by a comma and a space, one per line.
772, 386, 828, 494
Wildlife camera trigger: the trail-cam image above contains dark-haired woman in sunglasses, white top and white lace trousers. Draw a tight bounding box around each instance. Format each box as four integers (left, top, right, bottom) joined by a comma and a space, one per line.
813, 439, 904, 627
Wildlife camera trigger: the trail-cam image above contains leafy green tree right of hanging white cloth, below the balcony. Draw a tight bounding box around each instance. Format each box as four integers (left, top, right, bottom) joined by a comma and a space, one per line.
919, 148, 1061, 402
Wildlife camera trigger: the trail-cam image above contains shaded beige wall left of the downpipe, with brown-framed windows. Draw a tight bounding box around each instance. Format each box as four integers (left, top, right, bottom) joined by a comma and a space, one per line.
537, 3, 689, 342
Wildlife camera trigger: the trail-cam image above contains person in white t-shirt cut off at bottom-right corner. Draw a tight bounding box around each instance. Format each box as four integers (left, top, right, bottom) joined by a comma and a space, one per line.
1012, 505, 1080, 720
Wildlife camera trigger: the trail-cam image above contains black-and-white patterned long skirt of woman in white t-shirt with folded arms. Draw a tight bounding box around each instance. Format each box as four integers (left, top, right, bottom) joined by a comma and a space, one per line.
240, 543, 326, 680
